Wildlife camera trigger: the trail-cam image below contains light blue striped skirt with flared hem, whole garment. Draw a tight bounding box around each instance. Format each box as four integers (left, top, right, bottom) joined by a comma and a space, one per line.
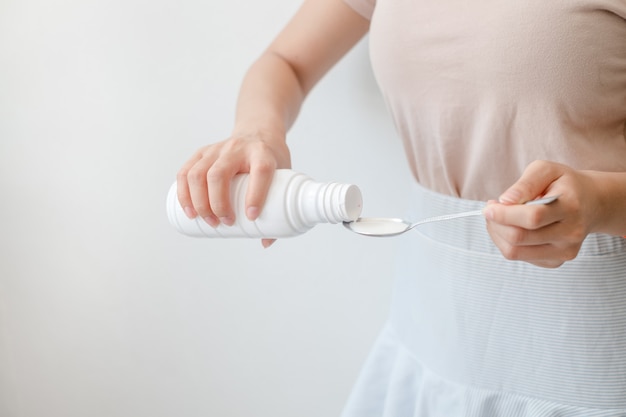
343, 185, 626, 417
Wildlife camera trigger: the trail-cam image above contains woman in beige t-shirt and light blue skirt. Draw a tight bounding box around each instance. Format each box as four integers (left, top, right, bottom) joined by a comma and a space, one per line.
178, 0, 626, 417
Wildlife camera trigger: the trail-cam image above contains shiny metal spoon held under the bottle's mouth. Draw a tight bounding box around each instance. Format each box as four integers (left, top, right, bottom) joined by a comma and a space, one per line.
343, 195, 559, 237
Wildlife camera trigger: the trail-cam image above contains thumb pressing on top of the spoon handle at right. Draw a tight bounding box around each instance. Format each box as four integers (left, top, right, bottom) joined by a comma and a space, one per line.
498, 161, 563, 204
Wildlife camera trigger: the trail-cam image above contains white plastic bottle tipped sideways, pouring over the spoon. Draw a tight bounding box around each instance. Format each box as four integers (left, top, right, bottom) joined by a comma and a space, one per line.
167, 169, 363, 238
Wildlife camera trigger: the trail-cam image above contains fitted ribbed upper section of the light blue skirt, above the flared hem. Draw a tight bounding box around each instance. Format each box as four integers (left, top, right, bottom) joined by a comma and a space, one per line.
390, 180, 626, 409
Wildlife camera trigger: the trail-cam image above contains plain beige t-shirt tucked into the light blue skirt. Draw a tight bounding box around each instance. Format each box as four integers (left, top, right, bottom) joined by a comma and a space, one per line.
344, 0, 626, 200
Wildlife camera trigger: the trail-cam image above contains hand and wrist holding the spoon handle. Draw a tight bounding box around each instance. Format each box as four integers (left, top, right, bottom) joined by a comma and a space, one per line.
485, 161, 626, 268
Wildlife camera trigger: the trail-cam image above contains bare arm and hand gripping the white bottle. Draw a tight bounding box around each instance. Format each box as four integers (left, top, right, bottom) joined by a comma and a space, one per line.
177, 0, 369, 231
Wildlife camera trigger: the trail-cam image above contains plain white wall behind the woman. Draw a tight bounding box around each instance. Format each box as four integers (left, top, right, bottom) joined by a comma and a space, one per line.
0, 0, 408, 417
